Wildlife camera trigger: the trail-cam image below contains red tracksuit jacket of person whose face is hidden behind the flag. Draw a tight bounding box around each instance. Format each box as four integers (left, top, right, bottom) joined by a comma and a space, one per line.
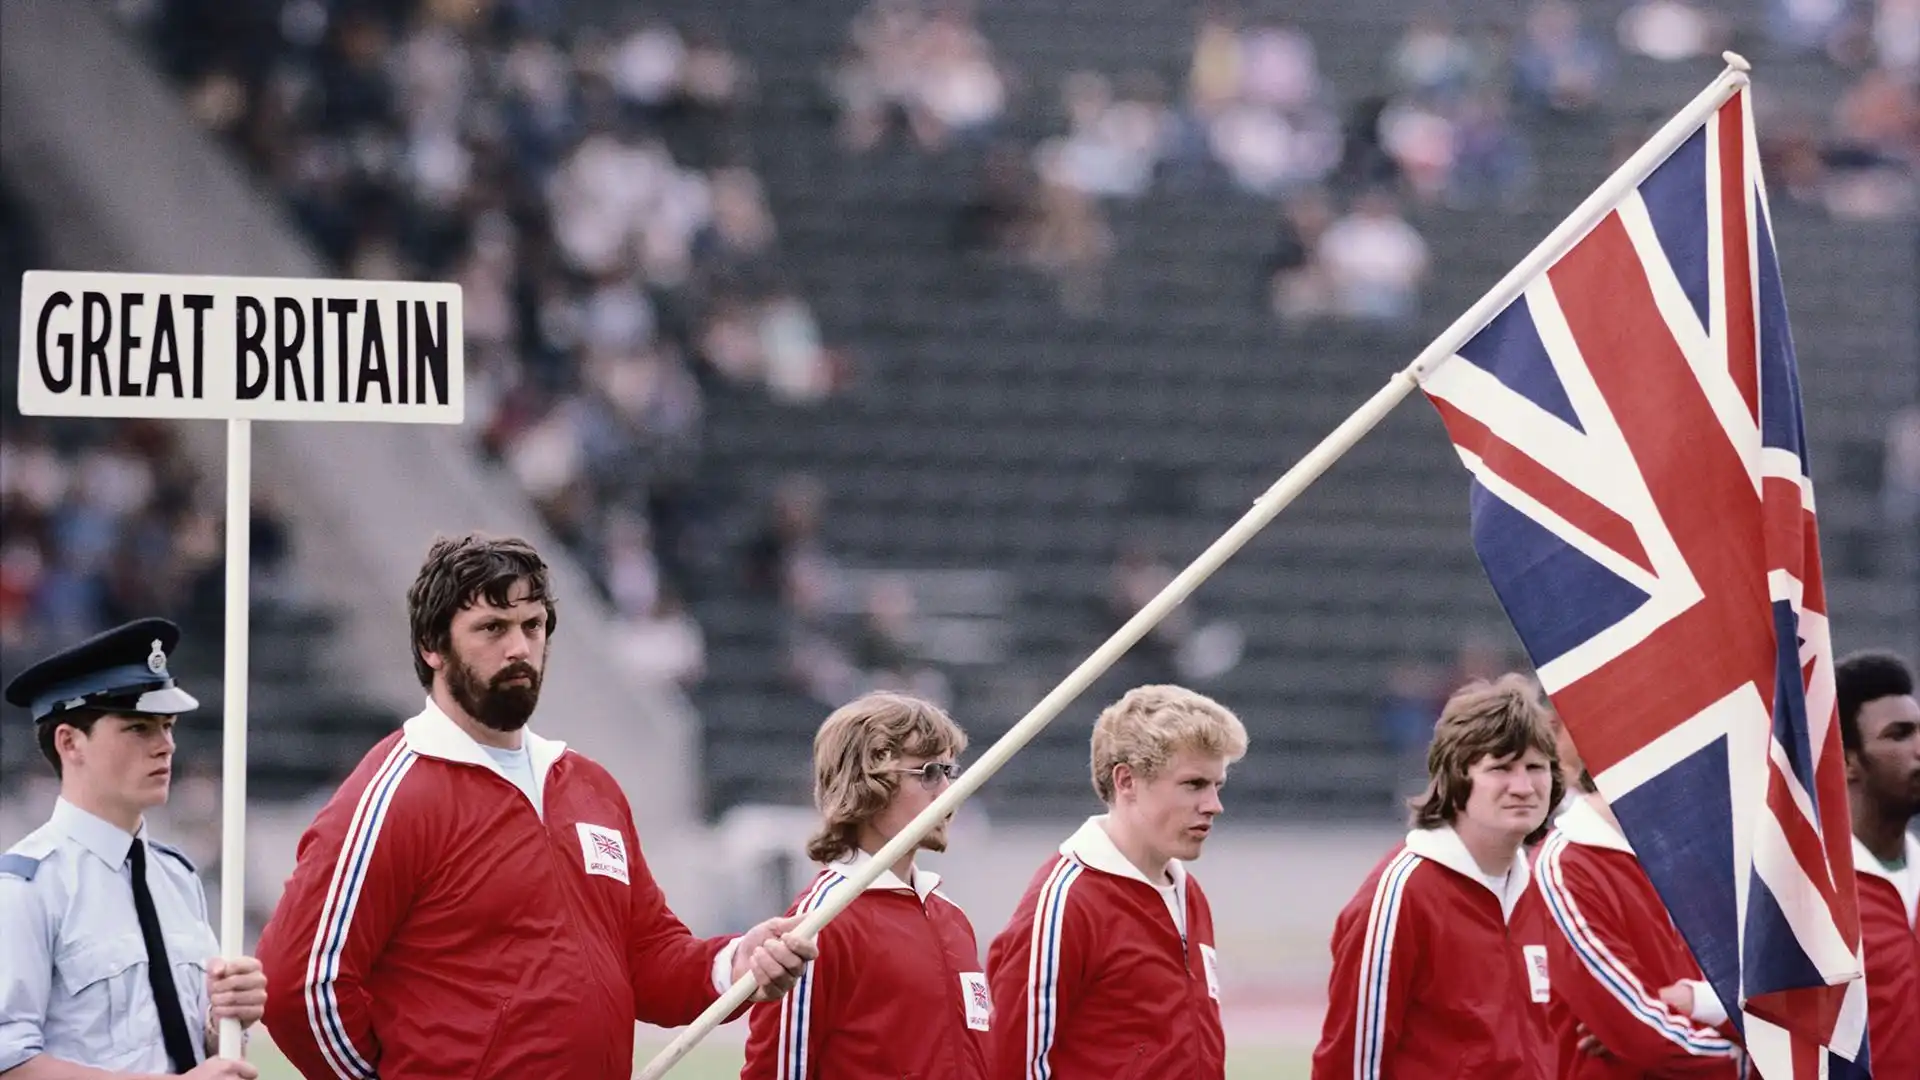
1534, 798, 1751, 1080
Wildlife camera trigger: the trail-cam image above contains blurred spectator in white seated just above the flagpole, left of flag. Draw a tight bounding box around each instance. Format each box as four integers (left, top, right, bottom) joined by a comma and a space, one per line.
1321, 192, 1428, 323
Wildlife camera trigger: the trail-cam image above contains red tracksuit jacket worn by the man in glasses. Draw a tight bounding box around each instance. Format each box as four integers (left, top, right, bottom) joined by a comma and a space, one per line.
741, 853, 993, 1080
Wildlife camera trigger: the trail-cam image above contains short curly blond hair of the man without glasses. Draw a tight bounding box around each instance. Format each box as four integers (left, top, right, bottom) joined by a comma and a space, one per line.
1092, 686, 1246, 803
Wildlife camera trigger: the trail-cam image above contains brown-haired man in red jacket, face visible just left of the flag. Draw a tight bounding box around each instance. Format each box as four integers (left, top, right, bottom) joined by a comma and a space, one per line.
1313, 675, 1561, 1080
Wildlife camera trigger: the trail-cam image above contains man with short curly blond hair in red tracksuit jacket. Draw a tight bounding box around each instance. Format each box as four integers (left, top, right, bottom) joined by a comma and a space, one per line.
987, 686, 1246, 1080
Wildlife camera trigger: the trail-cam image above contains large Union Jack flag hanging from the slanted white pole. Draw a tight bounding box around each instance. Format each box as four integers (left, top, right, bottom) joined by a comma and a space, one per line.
1421, 85, 1866, 1080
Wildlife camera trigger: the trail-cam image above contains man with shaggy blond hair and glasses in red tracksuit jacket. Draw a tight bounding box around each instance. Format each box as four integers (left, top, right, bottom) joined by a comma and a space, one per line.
741, 694, 993, 1080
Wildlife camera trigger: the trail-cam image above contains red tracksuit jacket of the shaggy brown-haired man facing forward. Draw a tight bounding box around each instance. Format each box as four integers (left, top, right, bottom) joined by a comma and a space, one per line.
1313, 826, 1553, 1080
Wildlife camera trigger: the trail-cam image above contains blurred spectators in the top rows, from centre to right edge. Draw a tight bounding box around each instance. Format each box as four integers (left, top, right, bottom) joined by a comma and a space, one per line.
860, 0, 1920, 323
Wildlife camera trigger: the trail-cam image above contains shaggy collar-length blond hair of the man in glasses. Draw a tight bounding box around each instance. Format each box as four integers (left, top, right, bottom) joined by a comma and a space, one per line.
806, 692, 966, 863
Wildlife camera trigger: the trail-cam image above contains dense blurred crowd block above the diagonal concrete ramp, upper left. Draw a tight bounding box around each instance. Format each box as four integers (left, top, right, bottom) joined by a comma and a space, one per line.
110, 0, 871, 682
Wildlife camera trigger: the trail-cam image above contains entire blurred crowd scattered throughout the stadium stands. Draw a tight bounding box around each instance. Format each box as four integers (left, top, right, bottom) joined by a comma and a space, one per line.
18, 0, 1889, 780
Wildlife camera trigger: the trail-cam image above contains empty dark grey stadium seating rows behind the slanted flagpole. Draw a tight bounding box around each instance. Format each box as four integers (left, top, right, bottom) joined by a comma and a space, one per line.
622, 0, 1920, 815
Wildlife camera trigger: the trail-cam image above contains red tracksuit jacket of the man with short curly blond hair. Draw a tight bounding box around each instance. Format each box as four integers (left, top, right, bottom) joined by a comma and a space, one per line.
987, 817, 1227, 1080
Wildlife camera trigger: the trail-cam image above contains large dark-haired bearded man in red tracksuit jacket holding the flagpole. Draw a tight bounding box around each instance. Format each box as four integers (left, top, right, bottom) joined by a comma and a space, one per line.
259, 534, 816, 1080
